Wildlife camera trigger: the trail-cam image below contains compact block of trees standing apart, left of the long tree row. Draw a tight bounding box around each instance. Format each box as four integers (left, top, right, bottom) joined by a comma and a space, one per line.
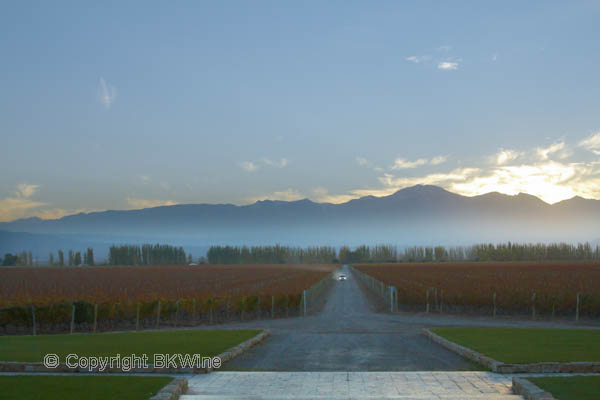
108, 244, 188, 265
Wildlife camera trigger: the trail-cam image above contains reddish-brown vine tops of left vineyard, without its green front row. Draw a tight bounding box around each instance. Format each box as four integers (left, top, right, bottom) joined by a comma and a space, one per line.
0, 264, 337, 307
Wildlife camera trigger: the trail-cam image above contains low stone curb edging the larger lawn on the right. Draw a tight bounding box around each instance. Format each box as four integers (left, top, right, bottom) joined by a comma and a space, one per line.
423, 329, 600, 374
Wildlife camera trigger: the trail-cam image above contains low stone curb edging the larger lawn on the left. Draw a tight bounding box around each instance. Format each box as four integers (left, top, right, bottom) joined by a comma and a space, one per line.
0, 330, 271, 374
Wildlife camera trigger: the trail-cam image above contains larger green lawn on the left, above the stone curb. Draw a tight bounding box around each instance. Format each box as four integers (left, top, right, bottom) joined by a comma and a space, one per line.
0, 330, 260, 363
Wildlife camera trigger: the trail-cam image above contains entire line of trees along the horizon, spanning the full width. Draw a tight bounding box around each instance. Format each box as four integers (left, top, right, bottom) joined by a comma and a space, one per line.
0, 242, 600, 266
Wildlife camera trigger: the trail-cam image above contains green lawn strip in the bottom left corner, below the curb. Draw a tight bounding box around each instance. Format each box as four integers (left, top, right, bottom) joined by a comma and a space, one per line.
0, 375, 173, 400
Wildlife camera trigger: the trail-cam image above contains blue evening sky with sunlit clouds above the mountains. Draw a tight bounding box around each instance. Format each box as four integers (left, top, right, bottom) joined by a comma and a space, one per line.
0, 0, 600, 221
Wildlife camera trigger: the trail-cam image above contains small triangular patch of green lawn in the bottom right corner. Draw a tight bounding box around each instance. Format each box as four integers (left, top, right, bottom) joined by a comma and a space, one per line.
528, 376, 600, 400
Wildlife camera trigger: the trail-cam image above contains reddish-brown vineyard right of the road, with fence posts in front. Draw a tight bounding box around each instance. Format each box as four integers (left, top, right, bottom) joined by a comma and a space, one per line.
354, 261, 600, 319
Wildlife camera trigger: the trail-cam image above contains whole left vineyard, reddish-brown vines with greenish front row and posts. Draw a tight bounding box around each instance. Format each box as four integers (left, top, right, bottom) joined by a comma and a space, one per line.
0, 264, 336, 333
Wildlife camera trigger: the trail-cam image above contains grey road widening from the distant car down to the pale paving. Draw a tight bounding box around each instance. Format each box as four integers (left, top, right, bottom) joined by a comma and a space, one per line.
224, 267, 477, 372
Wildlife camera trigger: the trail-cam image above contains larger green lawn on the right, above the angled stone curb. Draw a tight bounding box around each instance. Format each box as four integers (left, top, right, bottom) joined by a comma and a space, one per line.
432, 328, 600, 364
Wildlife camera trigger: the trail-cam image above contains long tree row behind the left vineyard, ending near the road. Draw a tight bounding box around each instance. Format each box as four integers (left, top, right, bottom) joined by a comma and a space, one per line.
207, 245, 338, 264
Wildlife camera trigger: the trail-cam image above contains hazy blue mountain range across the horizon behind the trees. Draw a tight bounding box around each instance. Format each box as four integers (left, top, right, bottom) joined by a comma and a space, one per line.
0, 185, 600, 257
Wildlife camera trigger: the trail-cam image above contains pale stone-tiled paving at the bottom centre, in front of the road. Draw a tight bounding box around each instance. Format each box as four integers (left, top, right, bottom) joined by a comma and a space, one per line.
181, 371, 522, 400
